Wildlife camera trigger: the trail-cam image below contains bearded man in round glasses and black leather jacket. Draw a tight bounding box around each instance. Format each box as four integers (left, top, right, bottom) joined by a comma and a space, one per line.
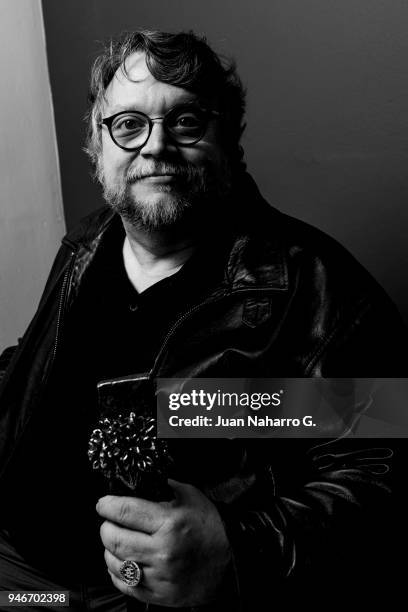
0, 32, 405, 610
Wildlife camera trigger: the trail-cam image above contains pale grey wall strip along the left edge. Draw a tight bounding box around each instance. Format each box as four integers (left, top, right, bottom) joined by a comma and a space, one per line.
0, 0, 65, 350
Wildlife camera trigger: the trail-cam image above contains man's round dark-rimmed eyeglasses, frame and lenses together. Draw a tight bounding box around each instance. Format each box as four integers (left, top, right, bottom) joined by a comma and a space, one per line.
99, 104, 220, 151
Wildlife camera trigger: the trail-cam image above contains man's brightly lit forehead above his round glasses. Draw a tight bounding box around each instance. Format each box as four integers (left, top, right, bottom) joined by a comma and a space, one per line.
105, 52, 196, 114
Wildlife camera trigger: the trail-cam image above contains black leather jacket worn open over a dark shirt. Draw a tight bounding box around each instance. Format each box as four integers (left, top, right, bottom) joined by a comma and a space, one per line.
0, 176, 406, 610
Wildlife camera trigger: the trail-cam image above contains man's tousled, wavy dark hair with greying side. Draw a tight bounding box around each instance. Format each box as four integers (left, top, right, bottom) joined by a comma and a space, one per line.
85, 30, 245, 173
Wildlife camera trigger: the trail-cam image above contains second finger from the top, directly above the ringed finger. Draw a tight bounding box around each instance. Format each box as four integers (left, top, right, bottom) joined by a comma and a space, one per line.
100, 521, 155, 564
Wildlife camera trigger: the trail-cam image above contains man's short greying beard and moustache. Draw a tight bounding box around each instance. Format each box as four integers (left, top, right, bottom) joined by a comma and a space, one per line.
97, 158, 232, 231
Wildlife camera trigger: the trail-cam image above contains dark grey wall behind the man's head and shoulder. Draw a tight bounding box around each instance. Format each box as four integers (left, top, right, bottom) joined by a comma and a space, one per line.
43, 0, 408, 321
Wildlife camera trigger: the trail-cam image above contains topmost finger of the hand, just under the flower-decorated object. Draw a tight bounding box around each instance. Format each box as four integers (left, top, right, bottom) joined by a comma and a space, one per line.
96, 495, 167, 534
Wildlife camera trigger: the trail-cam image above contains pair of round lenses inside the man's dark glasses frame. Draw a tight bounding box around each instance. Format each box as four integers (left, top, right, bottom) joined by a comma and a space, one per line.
111, 109, 206, 149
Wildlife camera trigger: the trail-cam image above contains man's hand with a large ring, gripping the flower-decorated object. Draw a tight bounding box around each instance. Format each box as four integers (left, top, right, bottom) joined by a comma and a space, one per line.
96, 480, 231, 607
